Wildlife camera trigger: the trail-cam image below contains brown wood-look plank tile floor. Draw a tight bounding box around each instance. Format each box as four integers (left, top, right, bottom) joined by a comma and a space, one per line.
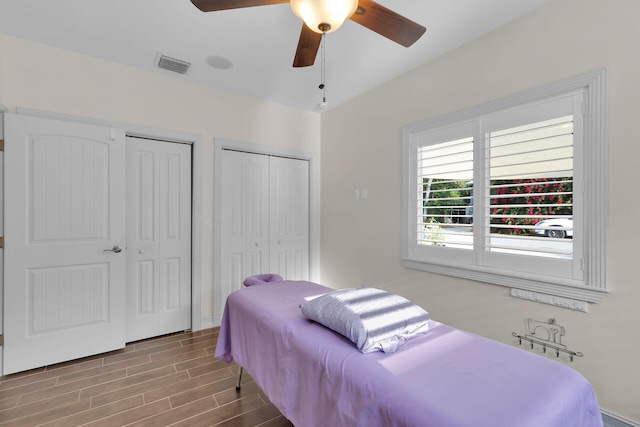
0, 328, 292, 427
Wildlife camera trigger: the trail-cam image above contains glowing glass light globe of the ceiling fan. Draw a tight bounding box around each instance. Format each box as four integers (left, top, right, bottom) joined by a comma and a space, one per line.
291, 0, 358, 34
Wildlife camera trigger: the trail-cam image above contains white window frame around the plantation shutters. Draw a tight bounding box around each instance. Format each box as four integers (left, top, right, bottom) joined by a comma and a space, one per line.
402, 69, 610, 304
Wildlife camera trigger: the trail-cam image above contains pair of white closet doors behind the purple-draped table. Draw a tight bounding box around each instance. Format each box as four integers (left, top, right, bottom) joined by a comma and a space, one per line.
213, 144, 310, 324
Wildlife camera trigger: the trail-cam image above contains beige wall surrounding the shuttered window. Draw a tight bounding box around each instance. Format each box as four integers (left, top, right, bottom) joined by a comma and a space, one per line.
321, 0, 640, 422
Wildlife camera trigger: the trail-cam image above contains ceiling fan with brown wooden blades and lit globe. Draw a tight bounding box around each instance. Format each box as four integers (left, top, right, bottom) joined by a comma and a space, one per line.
191, 0, 426, 67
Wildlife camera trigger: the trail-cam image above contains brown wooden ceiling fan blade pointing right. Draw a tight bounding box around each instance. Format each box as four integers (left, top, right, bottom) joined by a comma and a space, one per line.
349, 0, 427, 47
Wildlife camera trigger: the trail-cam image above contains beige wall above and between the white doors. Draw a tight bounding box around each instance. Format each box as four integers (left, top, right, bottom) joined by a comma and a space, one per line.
0, 33, 320, 324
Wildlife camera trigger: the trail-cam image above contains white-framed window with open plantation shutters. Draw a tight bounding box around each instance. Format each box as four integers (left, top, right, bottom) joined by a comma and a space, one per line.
403, 72, 607, 308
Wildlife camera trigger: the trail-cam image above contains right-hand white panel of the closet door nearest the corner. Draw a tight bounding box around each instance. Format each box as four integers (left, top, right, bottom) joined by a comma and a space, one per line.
269, 157, 309, 280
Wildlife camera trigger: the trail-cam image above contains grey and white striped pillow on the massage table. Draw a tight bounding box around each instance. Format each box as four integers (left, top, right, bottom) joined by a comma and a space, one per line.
300, 288, 429, 353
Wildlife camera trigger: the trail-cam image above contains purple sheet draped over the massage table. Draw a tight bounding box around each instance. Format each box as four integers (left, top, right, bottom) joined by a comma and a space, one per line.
216, 281, 603, 427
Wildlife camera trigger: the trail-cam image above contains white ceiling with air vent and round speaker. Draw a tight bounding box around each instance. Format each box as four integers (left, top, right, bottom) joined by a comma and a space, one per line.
0, 0, 549, 111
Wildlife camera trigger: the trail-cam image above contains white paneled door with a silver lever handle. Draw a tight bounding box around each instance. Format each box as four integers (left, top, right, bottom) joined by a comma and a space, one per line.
3, 114, 125, 374
